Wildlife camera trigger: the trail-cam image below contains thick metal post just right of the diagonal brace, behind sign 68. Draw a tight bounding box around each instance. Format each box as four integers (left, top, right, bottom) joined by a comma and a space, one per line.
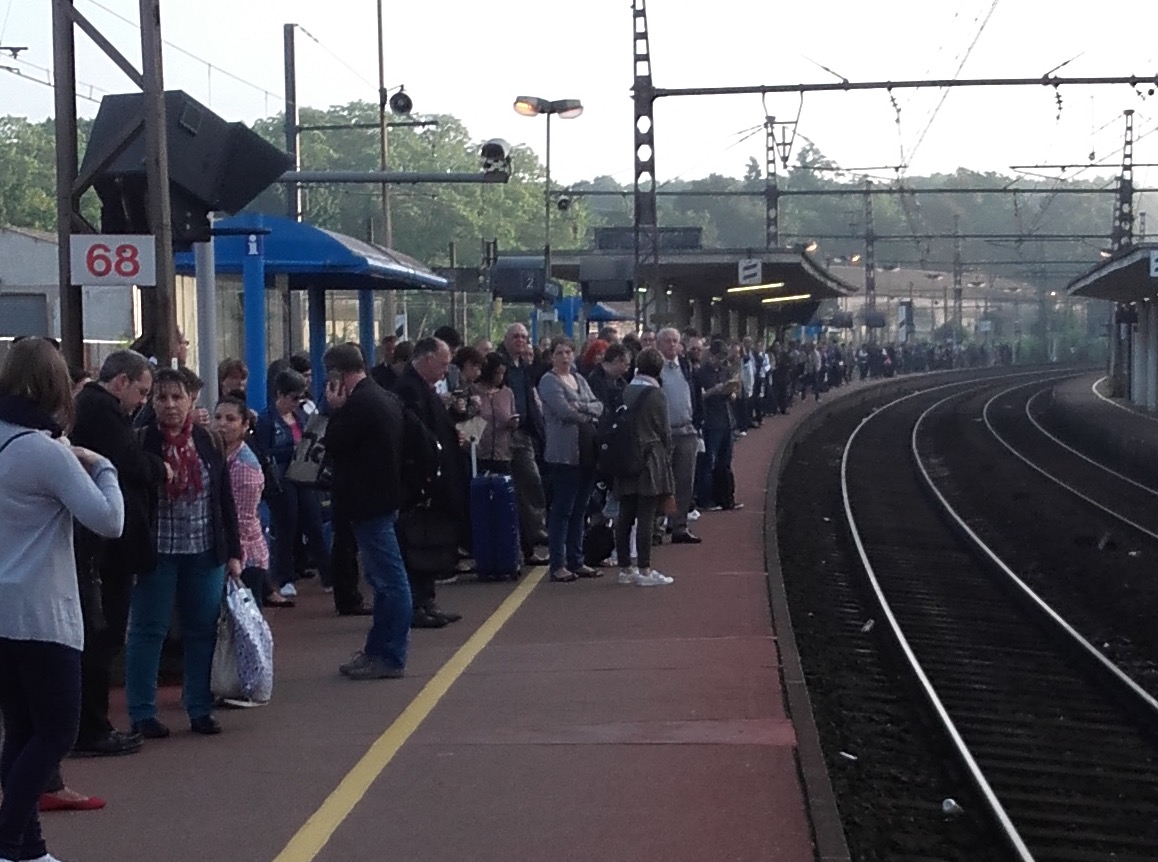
140, 0, 177, 366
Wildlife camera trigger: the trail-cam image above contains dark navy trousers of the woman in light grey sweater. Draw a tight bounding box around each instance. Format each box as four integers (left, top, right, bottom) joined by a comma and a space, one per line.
0, 637, 81, 859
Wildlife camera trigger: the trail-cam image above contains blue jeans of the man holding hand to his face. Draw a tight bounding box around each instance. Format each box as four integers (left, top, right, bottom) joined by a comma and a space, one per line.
353, 512, 413, 667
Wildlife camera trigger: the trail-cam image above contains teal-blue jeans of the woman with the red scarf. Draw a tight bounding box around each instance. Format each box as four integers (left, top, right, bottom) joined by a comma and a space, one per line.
125, 550, 225, 724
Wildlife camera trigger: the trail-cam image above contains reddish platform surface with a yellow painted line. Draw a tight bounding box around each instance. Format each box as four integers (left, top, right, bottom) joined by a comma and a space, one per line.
44, 403, 829, 862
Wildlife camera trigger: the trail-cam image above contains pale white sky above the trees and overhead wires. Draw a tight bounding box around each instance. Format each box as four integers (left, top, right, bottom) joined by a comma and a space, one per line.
0, 0, 1158, 193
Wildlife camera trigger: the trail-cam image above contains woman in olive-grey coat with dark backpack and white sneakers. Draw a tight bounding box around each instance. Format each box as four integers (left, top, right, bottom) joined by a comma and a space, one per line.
615, 348, 675, 586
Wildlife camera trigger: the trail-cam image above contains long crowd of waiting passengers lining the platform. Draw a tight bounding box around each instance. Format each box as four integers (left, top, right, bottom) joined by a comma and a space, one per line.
0, 323, 1009, 862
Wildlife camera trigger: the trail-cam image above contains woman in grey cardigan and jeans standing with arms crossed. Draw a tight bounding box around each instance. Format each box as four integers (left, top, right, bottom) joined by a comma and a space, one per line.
538, 337, 603, 582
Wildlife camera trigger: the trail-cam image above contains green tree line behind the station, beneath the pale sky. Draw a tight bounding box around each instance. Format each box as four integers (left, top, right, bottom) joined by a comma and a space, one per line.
0, 102, 1114, 280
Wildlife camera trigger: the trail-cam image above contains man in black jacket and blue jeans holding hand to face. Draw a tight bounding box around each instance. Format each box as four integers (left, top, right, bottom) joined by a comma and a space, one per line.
322, 344, 411, 680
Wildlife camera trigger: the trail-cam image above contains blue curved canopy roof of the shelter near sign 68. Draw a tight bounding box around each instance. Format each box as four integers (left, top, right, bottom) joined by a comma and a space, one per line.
175, 213, 448, 290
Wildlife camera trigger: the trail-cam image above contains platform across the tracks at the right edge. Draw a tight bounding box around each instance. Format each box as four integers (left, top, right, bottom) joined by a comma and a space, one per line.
1046, 372, 1158, 483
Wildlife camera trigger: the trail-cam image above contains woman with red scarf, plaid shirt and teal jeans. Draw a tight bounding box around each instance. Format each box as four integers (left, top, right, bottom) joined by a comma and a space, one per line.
125, 368, 242, 739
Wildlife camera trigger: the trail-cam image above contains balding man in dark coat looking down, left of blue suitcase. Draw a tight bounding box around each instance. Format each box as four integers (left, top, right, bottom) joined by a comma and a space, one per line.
394, 338, 470, 628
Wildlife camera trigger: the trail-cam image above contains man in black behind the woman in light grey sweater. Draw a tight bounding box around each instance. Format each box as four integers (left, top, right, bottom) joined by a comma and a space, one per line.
69, 350, 167, 757
